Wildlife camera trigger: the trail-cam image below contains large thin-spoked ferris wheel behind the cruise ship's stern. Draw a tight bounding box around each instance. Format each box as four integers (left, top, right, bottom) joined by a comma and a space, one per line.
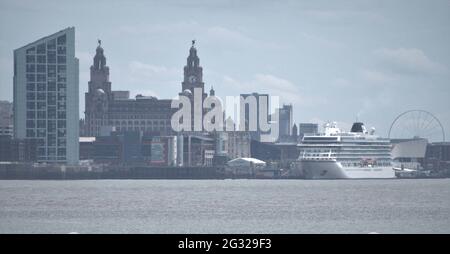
388, 110, 445, 142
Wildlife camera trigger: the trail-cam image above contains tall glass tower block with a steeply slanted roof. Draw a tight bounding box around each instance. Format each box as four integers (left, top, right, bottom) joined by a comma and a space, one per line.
14, 27, 79, 165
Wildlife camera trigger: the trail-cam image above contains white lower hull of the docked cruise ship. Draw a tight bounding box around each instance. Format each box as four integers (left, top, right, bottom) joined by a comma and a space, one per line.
300, 160, 395, 179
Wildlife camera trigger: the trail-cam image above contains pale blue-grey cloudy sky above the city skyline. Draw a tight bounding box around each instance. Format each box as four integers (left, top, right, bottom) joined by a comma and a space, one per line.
0, 0, 450, 139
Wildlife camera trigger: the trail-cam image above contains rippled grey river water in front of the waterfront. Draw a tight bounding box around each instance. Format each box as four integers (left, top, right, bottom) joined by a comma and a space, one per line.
0, 179, 450, 234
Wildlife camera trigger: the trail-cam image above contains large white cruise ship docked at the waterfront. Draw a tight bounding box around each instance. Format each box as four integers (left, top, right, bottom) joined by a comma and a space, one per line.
298, 122, 395, 179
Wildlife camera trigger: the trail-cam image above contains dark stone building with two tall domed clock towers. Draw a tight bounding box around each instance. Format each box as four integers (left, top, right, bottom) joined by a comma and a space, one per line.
84, 41, 214, 136
